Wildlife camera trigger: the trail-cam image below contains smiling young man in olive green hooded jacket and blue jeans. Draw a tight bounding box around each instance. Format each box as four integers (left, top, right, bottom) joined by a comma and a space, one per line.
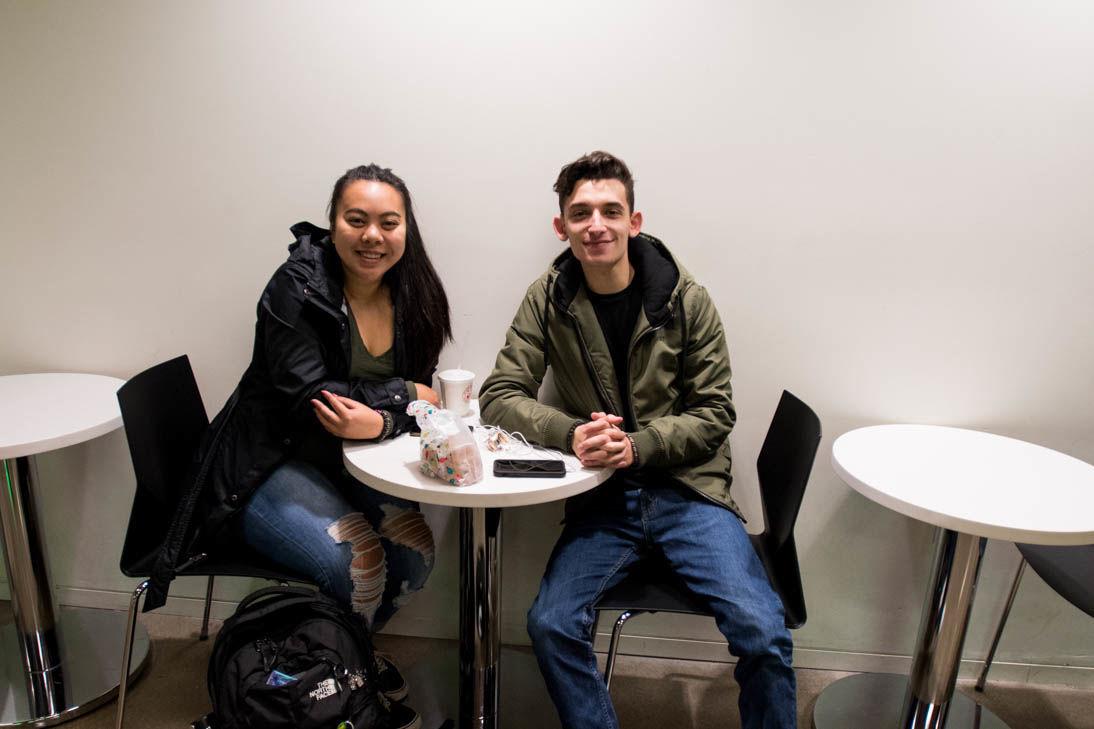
479, 152, 796, 729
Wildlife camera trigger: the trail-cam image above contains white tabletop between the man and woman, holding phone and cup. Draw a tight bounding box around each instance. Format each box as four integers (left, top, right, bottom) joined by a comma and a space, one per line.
342, 417, 614, 507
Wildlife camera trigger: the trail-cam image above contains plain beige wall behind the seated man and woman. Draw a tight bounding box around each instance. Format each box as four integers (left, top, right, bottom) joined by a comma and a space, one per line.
0, 0, 1094, 685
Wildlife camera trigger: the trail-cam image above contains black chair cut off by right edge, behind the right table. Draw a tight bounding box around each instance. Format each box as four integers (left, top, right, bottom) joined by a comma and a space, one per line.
976, 544, 1094, 691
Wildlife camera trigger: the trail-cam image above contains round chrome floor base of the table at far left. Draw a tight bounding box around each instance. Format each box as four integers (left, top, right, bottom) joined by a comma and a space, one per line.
0, 606, 149, 727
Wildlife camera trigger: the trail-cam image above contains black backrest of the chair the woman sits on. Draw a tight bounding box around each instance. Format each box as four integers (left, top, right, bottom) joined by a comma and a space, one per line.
118, 355, 209, 577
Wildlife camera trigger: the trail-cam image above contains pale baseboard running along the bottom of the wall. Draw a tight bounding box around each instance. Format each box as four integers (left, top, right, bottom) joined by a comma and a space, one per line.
38, 580, 1094, 690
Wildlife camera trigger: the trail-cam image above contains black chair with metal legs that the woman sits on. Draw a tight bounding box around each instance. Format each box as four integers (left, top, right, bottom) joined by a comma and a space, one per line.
115, 355, 309, 729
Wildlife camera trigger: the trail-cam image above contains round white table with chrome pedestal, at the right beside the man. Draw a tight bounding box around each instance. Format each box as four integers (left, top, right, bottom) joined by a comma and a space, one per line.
813, 425, 1094, 729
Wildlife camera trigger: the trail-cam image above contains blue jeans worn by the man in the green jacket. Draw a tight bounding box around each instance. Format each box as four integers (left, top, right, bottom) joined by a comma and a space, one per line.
528, 486, 798, 729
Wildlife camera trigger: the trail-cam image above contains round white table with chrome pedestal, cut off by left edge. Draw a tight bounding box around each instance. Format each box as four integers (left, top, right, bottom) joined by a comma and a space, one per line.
0, 373, 149, 727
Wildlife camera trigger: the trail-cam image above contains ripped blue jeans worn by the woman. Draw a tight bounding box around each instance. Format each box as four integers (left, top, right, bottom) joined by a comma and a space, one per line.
237, 461, 433, 630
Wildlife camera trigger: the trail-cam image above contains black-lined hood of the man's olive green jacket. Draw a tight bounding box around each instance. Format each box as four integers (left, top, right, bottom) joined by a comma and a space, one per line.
548, 233, 688, 327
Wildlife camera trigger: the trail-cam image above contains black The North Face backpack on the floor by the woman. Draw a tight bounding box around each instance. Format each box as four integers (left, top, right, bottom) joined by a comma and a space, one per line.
206, 587, 391, 729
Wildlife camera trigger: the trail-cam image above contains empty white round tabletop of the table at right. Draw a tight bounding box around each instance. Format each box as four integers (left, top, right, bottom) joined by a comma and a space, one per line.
831, 425, 1094, 545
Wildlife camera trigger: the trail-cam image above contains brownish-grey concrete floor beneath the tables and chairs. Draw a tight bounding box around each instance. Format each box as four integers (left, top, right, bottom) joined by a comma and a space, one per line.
0, 603, 1094, 729
